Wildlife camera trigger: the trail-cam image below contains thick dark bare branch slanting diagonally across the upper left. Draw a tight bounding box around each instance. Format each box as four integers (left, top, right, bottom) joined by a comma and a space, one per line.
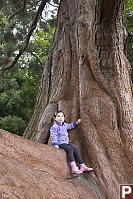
2, 0, 48, 71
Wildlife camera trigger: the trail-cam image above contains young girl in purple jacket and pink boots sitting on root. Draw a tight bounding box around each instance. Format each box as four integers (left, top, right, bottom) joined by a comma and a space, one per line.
50, 111, 93, 174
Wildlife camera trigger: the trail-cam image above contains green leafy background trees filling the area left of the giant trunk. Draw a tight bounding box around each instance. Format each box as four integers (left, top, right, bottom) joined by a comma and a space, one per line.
0, 1, 57, 135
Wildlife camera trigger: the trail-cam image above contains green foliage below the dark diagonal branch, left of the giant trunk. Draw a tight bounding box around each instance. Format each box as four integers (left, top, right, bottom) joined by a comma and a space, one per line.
0, 28, 54, 135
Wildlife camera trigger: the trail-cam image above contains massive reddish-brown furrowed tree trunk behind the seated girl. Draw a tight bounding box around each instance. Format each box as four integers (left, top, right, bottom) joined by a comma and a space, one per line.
24, 0, 133, 199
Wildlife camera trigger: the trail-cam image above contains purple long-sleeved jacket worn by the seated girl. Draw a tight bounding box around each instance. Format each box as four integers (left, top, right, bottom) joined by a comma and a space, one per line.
50, 122, 78, 145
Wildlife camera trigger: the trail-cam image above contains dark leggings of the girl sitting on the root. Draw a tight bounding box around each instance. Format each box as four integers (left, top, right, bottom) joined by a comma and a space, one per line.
59, 143, 83, 164
